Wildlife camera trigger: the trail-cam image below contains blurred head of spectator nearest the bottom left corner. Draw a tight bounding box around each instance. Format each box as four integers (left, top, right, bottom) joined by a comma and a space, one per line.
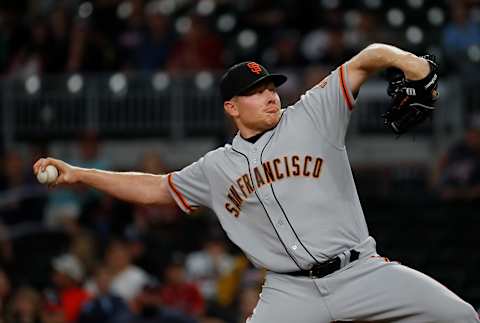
5, 287, 42, 323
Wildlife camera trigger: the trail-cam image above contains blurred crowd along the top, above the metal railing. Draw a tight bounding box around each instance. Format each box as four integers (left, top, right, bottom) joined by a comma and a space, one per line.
0, 0, 480, 77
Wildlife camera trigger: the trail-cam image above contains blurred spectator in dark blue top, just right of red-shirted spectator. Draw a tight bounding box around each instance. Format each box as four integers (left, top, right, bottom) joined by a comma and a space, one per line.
78, 266, 132, 323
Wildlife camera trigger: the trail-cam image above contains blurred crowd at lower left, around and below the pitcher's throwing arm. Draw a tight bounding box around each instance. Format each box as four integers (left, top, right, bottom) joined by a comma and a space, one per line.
0, 133, 264, 323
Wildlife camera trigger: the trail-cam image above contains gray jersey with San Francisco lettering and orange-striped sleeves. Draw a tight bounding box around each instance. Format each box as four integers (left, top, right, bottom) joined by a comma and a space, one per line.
169, 66, 368, 272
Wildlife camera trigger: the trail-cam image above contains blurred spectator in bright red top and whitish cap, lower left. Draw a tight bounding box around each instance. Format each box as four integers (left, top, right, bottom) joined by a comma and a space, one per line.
46, 254, 90, 323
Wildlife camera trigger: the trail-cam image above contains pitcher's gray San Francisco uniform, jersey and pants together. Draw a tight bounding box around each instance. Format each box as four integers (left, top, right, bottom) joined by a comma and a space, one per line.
168, 65, 480, 323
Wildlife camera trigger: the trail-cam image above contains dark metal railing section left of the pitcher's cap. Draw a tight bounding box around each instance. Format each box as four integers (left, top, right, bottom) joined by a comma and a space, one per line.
1, 75, 224, 145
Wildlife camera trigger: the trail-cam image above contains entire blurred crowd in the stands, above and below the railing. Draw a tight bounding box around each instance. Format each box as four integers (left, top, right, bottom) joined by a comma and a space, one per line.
0, 0, 480, 323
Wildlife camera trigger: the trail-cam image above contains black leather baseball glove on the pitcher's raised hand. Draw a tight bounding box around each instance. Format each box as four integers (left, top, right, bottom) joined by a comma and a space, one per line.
382, 55, 438, 135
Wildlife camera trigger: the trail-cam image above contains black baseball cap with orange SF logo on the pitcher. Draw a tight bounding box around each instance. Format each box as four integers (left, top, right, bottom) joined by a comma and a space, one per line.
220, 62, 287, 102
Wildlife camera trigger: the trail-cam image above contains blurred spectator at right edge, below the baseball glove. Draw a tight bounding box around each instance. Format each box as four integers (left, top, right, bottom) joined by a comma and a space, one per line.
433, 127, 480, 201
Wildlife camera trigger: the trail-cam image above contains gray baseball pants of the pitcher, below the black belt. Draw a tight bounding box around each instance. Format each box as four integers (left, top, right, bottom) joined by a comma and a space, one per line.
247, 249, 480, 323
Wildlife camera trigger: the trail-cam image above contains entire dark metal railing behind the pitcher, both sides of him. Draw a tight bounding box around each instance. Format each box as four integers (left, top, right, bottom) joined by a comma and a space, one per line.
0, 73, 472, 151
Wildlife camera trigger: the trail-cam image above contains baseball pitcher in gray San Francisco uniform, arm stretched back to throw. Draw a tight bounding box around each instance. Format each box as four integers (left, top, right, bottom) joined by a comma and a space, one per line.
33, 44, 480, 323
